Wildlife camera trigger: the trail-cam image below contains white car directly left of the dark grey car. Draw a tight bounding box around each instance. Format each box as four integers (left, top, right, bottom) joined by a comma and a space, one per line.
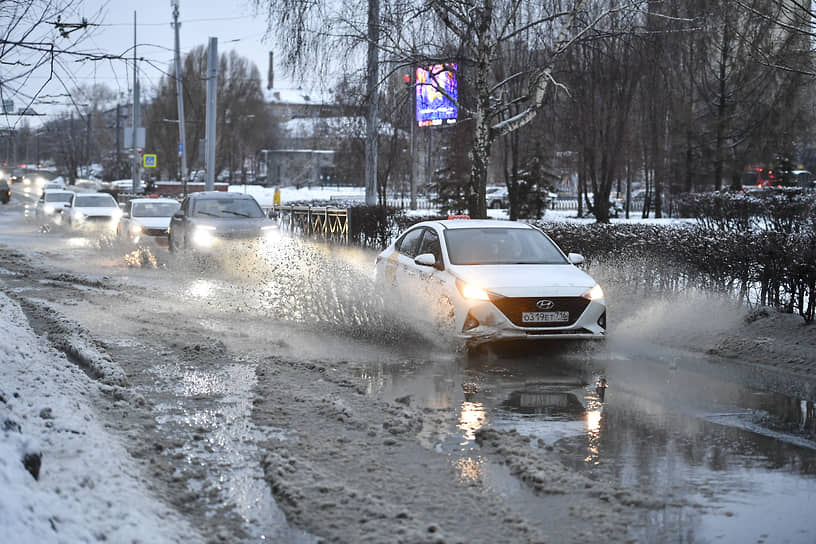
116, 198, 181, 246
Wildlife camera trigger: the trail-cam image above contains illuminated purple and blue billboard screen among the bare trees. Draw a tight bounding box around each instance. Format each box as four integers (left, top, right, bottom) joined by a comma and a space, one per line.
416, 63, 459, 127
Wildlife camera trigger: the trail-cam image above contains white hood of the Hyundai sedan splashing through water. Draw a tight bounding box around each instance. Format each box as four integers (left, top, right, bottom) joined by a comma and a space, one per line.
451, 264, 595, 297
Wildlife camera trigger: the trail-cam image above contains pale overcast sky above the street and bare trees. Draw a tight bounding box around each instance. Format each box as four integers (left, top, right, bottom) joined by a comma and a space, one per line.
8, 0, 297, 124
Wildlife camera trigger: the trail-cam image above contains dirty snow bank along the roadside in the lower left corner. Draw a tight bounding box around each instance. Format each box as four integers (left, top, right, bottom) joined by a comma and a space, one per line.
0, 293, 202, 543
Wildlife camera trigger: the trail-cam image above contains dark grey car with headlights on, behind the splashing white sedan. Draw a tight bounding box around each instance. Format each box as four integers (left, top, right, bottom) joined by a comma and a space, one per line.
169, 191, 278, 253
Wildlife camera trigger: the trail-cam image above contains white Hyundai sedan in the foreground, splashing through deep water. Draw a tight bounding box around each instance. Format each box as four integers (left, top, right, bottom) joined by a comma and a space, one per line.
375, 219, 606, 347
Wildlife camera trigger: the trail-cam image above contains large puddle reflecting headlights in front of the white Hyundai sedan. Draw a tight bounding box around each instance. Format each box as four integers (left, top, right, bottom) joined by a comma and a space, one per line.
363, 351, 816, 543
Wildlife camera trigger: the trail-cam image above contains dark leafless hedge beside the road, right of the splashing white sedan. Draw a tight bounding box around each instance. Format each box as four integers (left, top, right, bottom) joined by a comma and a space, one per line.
539, 223, 816, 322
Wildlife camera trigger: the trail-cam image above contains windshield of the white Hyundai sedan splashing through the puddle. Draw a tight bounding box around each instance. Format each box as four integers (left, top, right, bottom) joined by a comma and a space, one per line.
445, 227, 568, 265
